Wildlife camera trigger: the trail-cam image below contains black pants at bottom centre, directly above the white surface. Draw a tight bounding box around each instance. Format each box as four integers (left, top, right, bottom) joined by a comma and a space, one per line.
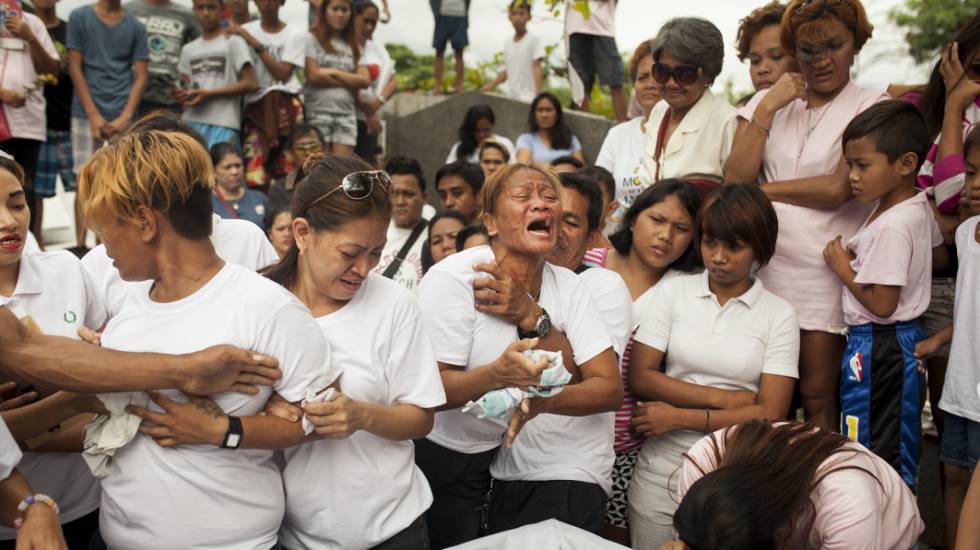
487, 479, 606, 534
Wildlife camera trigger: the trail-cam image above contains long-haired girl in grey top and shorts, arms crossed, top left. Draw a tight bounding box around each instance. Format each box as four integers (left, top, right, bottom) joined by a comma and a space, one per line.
303, 0, 371, 156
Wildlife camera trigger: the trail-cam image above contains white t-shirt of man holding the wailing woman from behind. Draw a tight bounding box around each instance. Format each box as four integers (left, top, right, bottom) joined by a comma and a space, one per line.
490, 267, 633, 496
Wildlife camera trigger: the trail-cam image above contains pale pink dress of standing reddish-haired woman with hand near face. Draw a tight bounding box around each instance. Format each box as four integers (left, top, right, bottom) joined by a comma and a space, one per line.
738, 82, 888, 332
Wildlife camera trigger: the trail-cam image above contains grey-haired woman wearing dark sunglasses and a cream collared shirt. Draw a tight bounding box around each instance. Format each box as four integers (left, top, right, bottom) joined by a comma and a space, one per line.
644, 17, 736, 182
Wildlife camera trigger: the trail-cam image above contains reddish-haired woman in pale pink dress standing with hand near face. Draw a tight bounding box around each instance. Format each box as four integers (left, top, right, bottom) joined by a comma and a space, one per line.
725, 0, 886, 430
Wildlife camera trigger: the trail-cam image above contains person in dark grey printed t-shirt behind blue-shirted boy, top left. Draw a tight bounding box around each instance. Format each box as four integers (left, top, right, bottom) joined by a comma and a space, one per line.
123, 0, 201, 114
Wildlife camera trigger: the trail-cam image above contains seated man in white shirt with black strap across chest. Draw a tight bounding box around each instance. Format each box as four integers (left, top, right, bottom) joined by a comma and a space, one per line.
374, 157, 429, 292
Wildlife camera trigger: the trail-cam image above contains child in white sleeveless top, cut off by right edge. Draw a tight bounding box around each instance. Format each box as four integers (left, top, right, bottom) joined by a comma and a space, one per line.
916, 126, 980, 548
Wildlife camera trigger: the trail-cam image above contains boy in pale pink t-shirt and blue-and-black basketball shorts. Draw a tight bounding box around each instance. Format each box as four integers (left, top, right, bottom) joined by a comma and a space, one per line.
823, 100, 946, 487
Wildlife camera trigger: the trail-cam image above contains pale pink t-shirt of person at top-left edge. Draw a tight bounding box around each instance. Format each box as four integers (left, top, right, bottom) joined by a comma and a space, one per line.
0, 13, 58, 141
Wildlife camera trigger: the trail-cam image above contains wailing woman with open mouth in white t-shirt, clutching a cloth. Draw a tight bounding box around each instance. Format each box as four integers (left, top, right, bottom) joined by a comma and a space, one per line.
416, 164, 623, 548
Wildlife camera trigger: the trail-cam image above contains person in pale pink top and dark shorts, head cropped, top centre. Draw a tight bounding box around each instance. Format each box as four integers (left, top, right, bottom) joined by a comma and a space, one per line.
565, 0, 626, 122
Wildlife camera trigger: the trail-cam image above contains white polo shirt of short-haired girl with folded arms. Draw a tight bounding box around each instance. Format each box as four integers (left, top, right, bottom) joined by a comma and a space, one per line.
634, 271, 800, 462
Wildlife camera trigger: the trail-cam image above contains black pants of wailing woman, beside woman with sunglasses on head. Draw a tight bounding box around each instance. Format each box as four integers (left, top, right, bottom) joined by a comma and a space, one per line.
415, 439, 497, 548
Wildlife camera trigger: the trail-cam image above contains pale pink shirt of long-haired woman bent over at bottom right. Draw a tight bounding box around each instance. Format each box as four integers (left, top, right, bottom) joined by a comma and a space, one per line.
677, 430, 925, 550
